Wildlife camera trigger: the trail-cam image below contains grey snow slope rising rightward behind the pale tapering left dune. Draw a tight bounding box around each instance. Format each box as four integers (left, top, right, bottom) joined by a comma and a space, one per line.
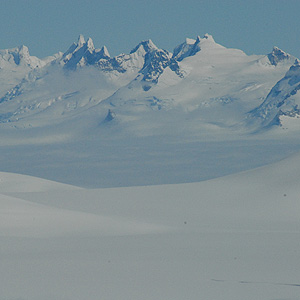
12, 153, 300, 231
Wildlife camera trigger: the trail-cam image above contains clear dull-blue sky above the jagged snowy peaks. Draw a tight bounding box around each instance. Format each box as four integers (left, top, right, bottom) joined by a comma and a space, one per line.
0, 0, 300, 58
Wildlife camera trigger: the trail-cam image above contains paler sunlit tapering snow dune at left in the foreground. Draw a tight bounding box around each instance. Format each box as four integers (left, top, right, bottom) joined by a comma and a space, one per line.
0, 195, 163, 238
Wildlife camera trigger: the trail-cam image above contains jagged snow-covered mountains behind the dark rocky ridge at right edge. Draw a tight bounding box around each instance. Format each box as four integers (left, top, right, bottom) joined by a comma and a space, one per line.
0, 34, 296, 135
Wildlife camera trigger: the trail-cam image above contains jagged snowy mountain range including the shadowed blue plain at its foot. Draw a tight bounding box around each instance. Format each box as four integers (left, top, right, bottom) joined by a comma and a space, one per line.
0, 34, 300, 187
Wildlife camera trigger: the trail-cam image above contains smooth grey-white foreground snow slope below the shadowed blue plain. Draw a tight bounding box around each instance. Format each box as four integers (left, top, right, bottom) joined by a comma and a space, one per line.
0, 154, 300, 300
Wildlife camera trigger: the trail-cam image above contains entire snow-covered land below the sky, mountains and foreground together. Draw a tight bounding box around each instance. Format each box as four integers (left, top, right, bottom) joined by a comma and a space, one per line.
0, 34, 300, 300
